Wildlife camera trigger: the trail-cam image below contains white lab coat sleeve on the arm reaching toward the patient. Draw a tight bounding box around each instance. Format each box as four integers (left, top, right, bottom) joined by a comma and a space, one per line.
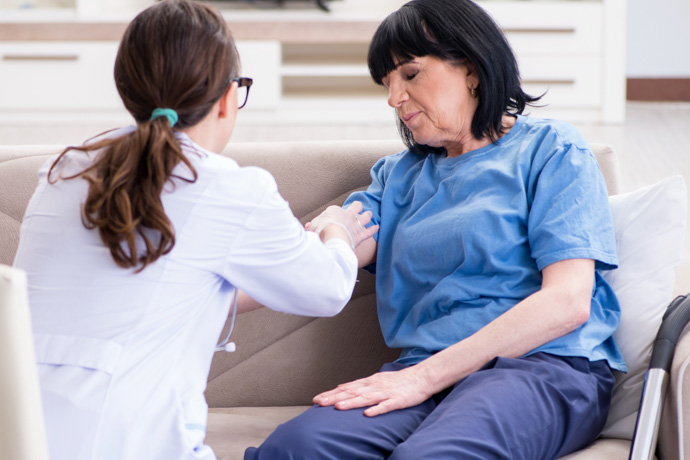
224, 169, 357, 316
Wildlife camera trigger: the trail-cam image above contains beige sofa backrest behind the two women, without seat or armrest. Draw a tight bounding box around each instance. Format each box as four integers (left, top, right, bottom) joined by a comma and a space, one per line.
0, 141, 620, 407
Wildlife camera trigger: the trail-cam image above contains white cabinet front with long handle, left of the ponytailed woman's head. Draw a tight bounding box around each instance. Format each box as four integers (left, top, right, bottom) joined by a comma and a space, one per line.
0, 42, 124, 111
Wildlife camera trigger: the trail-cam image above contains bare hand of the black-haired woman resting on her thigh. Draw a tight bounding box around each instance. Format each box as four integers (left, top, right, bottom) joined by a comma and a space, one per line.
314, 367, 433, 417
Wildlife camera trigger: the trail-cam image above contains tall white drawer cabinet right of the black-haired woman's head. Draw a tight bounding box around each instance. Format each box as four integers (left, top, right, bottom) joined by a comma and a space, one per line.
480, 0, 625, 123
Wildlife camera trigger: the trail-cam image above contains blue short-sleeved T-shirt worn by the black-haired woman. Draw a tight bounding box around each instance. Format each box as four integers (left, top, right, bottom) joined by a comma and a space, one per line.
347, 116, 625, 371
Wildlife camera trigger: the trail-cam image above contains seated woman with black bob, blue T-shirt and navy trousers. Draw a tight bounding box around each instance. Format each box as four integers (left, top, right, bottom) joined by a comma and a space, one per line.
245, 0, 625, 460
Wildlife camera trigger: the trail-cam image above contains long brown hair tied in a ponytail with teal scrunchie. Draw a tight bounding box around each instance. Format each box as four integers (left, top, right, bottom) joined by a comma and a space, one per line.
48, 0, 239, 271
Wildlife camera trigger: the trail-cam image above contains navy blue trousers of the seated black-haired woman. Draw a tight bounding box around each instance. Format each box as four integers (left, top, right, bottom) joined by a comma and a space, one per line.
244, 353, 614, 460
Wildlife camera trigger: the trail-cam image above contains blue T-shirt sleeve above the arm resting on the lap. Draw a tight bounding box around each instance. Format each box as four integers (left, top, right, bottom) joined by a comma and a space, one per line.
528, 145, 618, 270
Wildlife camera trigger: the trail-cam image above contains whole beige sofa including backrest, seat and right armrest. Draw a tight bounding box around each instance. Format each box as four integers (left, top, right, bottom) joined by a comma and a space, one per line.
0, 141, 690, 460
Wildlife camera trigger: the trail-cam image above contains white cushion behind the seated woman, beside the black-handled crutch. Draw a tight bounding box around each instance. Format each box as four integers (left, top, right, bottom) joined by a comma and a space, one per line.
603, 176, 687, 439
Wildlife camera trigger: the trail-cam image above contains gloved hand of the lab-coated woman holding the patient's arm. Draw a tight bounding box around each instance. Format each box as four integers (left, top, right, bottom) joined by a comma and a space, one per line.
304, 201, 379, 250
